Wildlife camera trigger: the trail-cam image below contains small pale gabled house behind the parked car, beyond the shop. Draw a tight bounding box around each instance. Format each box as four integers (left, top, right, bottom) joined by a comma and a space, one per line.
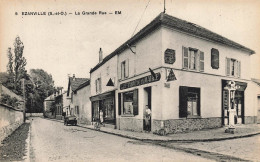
66, 74, 91, 124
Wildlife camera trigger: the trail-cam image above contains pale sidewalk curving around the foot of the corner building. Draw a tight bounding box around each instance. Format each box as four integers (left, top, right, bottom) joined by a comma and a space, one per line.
42, 118, 260, 142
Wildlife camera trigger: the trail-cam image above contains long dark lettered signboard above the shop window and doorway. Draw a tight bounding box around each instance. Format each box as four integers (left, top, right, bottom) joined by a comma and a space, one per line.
120, 73, 161, 90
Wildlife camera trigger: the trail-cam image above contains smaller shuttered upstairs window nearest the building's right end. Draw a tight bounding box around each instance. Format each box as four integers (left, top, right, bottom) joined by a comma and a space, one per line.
226, 58, 241, 77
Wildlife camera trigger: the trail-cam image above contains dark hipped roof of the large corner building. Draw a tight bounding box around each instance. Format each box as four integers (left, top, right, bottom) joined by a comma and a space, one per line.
90, 13, 255, 73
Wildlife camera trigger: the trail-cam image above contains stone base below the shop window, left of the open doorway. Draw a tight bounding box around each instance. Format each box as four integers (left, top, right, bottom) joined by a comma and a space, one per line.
118, 117, 143, 132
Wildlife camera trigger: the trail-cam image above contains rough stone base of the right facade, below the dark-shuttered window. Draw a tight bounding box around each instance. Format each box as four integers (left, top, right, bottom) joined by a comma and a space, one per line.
152, 117, 222, 133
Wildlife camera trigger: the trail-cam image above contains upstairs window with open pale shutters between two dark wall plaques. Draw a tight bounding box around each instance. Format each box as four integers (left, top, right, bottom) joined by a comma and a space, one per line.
182, 47, 204, 71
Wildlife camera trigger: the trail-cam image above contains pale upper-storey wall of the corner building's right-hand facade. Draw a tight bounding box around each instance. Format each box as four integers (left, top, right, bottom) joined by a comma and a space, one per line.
161, 27, 251, 80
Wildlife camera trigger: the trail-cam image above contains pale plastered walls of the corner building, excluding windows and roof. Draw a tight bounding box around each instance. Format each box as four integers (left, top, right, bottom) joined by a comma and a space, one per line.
116, 27, 257, 133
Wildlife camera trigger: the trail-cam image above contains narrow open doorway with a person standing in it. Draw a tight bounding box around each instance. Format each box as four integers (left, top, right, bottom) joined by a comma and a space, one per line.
143, 87, 152, 131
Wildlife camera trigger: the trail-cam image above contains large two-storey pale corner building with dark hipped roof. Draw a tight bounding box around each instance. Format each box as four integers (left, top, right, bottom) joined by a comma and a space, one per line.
91, 13, 257, 133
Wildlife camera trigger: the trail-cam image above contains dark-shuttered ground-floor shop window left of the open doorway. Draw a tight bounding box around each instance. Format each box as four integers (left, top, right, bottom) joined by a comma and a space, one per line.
118, 89, 138, 115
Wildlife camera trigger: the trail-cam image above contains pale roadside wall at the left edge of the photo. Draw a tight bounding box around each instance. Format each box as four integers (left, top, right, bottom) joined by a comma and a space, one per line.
0, 103, 23, 142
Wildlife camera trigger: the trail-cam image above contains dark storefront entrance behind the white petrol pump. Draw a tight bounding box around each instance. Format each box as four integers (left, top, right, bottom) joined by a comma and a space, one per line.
222, 80, 247, 125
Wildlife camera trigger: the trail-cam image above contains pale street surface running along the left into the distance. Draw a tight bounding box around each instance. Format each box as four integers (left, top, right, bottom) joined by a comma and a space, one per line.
30, 118, 209, 162
